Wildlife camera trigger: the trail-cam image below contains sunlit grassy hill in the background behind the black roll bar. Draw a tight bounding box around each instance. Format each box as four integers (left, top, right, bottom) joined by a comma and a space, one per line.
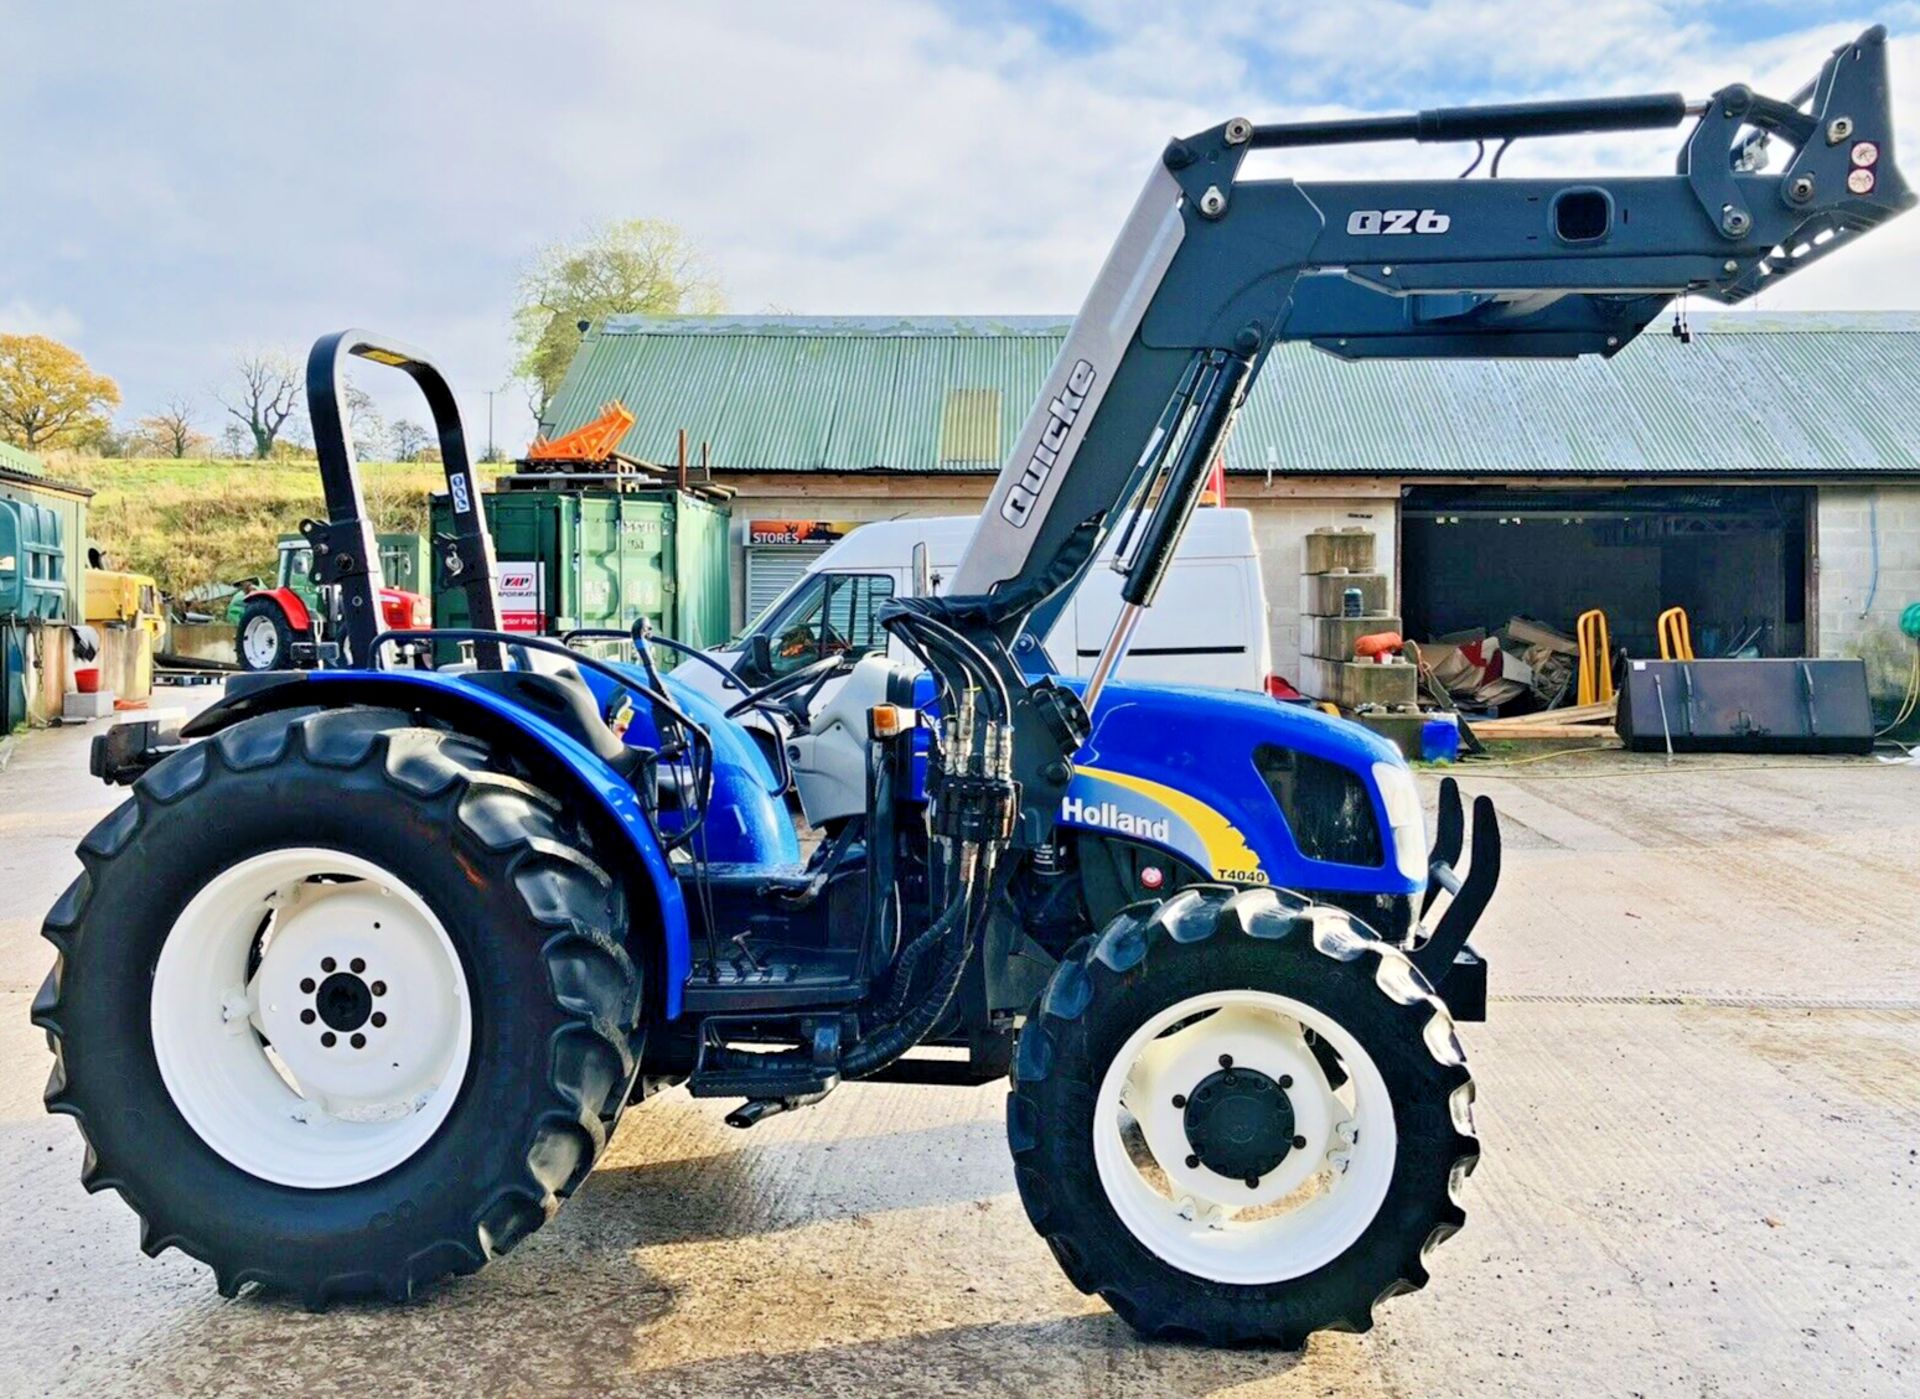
64, 459, 499, 593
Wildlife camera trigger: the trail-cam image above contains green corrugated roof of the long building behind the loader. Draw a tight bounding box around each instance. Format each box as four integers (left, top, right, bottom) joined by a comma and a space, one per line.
545, 313, 1920, 476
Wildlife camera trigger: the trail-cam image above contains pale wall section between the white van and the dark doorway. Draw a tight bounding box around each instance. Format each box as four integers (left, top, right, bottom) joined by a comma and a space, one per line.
1227, 476, 1400, 685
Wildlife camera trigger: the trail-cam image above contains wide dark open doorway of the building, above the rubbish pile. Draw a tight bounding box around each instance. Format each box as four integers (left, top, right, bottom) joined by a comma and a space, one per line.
1400, 486, 1812, 658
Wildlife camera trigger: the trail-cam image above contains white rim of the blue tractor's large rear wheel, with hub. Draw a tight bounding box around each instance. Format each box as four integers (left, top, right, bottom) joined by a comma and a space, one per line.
152, 848, 472, 1190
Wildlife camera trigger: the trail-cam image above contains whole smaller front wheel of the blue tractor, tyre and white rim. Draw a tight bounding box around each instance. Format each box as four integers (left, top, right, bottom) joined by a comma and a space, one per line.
1008, 889, 1478, 1349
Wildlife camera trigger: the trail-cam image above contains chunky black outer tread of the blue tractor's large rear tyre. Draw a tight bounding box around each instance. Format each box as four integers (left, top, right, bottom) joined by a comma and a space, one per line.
33, 708, 643, 1307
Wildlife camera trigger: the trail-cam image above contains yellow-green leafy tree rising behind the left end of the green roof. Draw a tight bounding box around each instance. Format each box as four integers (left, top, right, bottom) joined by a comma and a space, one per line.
513, 219, 724, 416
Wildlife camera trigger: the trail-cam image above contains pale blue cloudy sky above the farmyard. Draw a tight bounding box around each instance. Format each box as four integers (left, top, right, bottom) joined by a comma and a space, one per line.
0, 0, 1920, 447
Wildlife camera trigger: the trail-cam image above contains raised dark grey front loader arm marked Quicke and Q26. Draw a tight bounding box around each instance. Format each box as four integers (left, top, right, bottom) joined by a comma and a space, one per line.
914, 27, 1914, 839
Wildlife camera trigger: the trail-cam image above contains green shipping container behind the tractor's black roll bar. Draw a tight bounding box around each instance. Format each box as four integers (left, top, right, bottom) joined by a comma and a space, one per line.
434, 489, 730, 647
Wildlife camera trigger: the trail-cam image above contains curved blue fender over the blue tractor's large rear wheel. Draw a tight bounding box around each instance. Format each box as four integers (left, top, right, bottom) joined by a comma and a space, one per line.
180, 670, 691, 1019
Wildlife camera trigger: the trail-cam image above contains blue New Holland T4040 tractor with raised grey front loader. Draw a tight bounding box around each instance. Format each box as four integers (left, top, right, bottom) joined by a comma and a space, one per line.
33, 29, 1912, 1345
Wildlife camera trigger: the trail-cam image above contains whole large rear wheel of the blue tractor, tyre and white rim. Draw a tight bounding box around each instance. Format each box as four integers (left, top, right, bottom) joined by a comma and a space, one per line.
33, 708, 641, 1307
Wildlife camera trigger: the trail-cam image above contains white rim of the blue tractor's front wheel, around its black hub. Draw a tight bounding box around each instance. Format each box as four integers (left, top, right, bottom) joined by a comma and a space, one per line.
1092, 990, 1398, 1286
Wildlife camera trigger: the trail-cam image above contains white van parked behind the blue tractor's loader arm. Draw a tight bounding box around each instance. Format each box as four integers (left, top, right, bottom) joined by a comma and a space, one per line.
674, 509, 1273, 710
